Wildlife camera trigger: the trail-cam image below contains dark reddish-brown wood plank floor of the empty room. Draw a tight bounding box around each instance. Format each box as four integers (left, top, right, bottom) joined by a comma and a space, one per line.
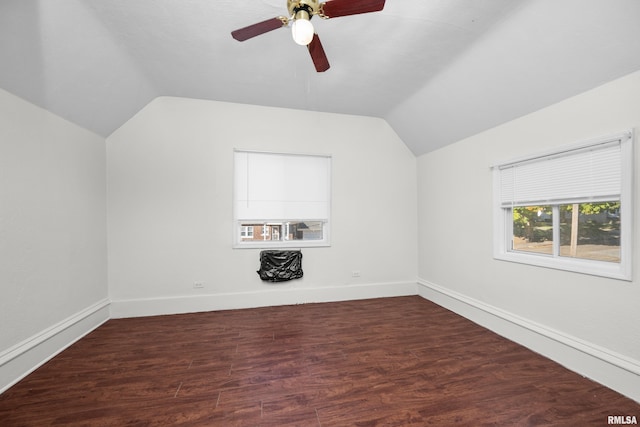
0, 297, 640, 427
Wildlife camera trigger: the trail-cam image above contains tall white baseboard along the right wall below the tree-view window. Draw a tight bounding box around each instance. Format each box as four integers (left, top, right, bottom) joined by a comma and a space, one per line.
418, 278, 640, 402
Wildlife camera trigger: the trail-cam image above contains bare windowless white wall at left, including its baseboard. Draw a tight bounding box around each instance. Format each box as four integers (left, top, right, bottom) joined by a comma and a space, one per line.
0, 89, 108, 392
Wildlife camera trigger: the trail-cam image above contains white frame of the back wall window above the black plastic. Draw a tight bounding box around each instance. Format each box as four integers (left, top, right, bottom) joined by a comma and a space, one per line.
233, 149, 332, 249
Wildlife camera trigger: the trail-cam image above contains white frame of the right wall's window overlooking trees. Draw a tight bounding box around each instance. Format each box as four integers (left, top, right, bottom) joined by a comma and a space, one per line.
492, 130, 635, 281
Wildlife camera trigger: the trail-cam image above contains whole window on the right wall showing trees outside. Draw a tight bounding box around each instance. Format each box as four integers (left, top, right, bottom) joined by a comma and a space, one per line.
493, 131, 633, 280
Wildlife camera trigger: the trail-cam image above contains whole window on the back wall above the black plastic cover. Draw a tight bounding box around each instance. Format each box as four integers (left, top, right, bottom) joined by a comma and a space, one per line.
234, 150, 331, 248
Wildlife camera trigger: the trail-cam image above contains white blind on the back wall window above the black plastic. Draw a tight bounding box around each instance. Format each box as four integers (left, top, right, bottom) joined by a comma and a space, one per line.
234, 151, 331, 221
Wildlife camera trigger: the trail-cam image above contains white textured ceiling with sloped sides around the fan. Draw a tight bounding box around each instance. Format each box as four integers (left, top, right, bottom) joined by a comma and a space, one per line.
0, 0, 640, 155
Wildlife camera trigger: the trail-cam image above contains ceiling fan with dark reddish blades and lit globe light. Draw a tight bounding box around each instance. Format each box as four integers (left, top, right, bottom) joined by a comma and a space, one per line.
231, 0, 385, 73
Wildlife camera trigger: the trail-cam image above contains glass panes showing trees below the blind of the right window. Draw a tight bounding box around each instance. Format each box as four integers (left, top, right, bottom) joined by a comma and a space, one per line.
512, 201, 620, 263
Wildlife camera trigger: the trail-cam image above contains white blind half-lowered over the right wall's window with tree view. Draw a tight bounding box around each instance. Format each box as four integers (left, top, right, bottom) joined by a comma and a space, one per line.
498, 136, 624, 207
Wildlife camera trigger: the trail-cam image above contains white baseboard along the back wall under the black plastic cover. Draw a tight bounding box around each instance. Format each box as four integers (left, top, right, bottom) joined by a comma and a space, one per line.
111, 282, 417, 319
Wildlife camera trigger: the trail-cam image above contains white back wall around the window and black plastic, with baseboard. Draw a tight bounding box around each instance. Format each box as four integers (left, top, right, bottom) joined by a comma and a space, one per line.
107, 97, 417, 317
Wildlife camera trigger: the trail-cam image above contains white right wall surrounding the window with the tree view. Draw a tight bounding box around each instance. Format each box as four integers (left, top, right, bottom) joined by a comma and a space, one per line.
418, 72, 640, 400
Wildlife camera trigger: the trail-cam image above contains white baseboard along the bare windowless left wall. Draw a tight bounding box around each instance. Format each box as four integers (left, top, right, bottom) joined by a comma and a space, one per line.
0, 299, 109, 394
